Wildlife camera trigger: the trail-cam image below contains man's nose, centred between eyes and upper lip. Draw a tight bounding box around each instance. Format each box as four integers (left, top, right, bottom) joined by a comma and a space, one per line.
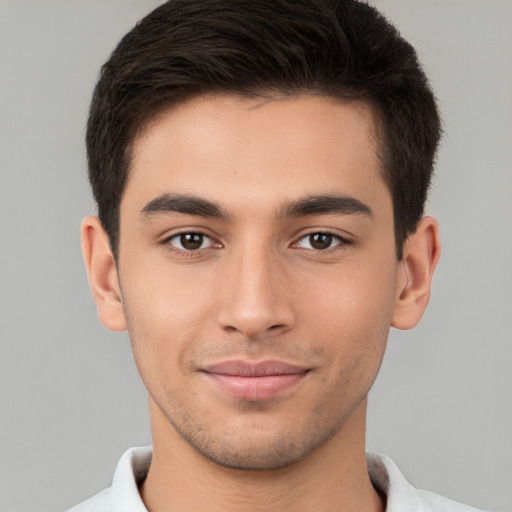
218, 244, 295, 340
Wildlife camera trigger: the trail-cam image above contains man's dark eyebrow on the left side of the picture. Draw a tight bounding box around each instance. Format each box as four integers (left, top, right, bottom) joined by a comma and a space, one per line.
140, 194, 229, 220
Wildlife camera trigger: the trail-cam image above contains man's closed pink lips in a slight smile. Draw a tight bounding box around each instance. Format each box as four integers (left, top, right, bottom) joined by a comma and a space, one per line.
202, 360, 310, 401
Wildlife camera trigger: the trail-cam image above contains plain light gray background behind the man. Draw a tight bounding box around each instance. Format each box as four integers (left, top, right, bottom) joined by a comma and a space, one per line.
0, 0, 512, 512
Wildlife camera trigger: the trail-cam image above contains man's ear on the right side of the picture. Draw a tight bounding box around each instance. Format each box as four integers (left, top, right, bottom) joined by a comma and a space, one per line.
391, 217, 441, 329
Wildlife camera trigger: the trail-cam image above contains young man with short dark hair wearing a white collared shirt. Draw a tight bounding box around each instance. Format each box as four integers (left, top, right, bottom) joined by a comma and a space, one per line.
69, 0, 488, 512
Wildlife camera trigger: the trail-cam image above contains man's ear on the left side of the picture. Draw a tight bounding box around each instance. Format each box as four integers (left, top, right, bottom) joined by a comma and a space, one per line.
81, 216, 126, 331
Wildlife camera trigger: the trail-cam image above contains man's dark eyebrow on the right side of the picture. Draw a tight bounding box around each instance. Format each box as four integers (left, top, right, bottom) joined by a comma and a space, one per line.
280, 194, 373, 218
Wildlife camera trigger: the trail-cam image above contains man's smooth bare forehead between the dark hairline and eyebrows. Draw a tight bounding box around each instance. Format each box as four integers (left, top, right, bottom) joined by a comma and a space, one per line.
121, 96, 387, 214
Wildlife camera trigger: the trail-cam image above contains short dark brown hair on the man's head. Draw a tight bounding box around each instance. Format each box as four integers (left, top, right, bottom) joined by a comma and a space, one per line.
87, 0, 440, 259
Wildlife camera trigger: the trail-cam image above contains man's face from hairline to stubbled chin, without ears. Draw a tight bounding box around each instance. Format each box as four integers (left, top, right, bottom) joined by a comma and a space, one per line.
118, 96, 399, 468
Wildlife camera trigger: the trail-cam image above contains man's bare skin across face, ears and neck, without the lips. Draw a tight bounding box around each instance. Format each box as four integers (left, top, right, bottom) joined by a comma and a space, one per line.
82, 96, 439, 511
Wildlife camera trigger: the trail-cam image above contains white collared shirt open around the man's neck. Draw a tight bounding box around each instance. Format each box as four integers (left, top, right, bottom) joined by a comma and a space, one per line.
67, 446, 483, 512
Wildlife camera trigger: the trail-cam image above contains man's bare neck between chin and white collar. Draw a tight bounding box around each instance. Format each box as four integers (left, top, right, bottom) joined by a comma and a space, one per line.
141, 401, 385, 512
